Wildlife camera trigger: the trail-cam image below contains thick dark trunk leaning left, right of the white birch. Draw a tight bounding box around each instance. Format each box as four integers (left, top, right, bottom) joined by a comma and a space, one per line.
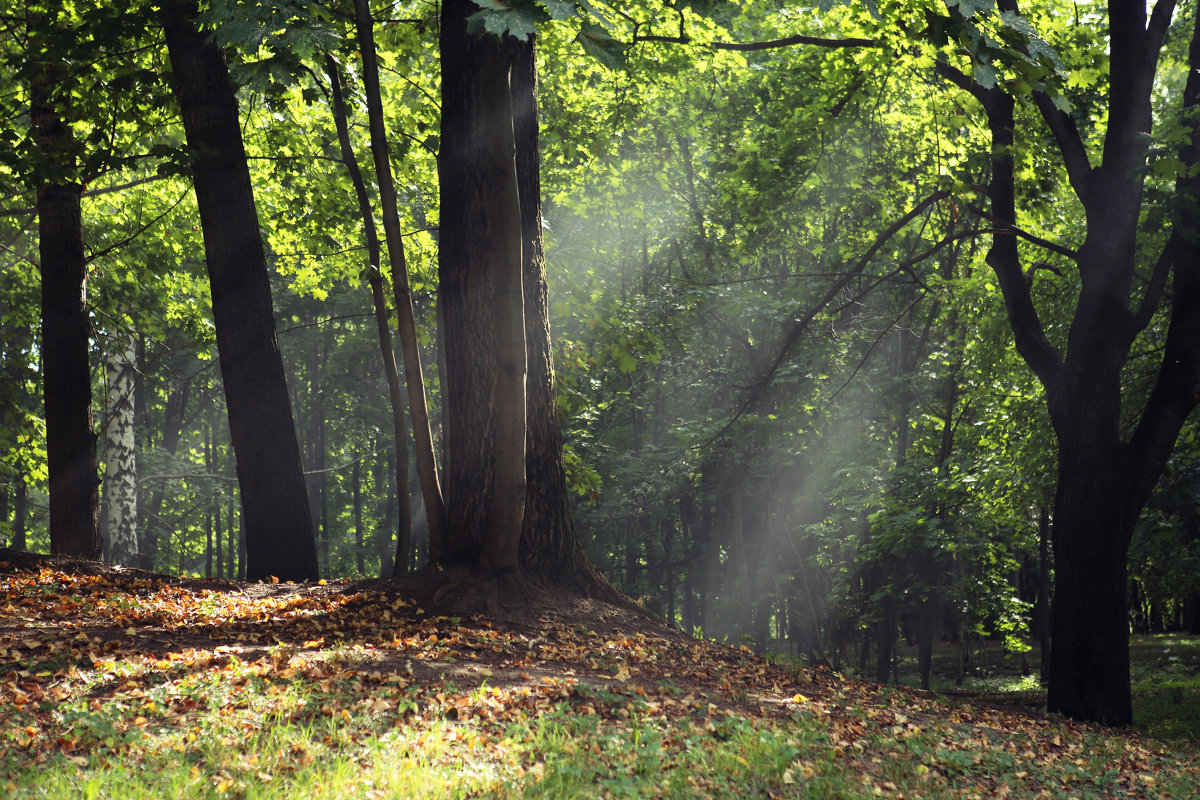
163, 1, 318, 581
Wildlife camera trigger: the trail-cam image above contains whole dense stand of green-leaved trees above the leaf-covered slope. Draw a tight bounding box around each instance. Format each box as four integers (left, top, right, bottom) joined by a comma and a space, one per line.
0, 0, 1200, 723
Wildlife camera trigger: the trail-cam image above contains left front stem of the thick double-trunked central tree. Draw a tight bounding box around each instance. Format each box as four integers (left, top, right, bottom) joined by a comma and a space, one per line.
438, 0, 524, 571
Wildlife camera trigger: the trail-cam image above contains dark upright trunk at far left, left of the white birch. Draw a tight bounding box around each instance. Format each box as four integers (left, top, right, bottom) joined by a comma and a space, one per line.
30, 42, 103, 559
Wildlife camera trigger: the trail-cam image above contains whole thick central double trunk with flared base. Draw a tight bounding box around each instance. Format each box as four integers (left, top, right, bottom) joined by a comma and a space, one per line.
438, 0, 616, 596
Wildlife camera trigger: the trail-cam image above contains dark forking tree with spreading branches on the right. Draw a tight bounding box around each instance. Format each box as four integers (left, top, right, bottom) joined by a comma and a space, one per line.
940, 0, 1200, 724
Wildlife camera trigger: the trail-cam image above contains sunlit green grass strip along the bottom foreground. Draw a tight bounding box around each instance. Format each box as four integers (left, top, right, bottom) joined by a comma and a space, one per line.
6, 684, 1195, 800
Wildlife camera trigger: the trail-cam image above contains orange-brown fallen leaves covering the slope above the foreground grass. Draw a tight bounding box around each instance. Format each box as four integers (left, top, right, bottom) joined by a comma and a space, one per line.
0, 553, 1200, 798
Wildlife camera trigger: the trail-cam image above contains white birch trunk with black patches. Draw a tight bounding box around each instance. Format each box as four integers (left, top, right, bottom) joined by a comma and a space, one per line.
104, 333, 138, 566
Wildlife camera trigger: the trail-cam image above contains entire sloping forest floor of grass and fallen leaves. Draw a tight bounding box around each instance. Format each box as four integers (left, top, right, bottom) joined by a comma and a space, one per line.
0, 551, 1200, 800
